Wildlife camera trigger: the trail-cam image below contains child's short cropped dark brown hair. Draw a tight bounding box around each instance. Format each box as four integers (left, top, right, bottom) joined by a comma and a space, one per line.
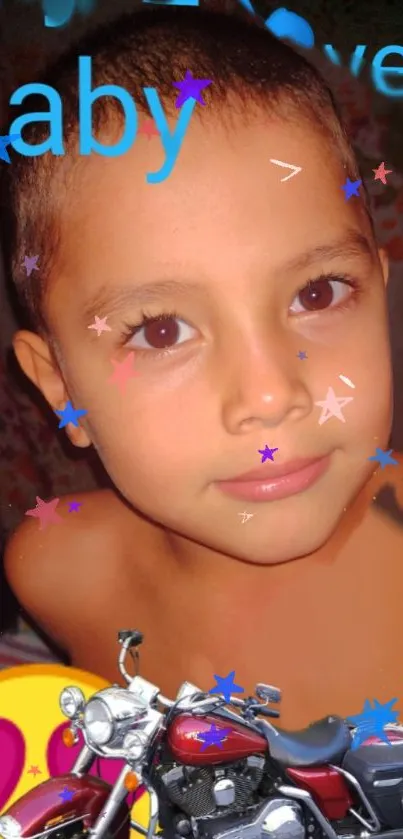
1, 6, 366, 337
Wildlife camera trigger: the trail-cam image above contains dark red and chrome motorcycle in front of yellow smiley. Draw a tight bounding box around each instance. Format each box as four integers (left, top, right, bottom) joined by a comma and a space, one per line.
0, 630, 403, 839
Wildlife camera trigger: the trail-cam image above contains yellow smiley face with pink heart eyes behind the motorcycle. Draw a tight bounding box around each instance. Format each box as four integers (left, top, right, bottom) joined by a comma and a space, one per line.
0, 664, 149, 839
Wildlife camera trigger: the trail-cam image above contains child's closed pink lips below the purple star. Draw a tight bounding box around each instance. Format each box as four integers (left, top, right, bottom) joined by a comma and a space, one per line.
216, 455, 331, 501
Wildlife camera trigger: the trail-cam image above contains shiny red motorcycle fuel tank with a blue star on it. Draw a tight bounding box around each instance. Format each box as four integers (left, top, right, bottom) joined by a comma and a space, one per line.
168, 714, 268, 766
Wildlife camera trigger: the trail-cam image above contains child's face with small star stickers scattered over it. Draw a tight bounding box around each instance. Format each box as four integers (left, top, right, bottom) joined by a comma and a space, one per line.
15, 106, 392, 564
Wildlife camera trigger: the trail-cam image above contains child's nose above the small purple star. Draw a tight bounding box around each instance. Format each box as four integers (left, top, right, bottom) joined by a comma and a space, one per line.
222, 342, 313, 434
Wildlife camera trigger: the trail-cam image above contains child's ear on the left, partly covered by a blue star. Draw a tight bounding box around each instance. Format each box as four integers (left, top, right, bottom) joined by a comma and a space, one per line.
13, 329, 91, 448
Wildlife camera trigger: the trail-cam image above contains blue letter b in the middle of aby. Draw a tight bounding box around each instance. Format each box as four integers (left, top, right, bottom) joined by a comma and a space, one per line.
78, 55, 137, 157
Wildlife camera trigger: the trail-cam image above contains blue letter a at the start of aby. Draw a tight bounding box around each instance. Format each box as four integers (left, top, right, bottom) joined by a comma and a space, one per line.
8, 83, 64, 157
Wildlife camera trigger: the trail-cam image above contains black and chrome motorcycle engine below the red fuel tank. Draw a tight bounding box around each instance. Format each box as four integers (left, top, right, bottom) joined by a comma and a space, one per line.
160, 755, 306, 839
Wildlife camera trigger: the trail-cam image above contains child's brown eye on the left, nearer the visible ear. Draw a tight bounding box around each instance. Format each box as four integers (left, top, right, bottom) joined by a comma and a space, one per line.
125, 314, 196, 350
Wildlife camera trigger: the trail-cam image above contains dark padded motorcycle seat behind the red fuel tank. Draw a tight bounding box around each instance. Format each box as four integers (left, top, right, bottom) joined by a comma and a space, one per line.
255, 717, 352, 768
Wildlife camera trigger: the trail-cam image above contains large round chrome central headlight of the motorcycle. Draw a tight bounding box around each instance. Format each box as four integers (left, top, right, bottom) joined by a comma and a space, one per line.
84, 686, 148, 748
